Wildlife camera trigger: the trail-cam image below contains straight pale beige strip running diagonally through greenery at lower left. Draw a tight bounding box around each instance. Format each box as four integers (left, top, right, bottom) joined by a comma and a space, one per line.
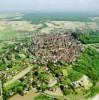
4, 66, 33, 86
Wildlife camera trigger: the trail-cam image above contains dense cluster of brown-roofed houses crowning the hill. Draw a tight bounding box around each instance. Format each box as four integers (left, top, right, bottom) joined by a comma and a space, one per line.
31, 33, 82, 63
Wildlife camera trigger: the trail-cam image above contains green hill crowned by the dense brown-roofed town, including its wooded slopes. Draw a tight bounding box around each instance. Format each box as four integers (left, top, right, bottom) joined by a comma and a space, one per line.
0, 32, 99, 100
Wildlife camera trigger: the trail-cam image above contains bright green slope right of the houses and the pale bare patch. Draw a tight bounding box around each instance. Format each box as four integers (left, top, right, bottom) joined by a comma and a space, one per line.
74, 47, 99, 96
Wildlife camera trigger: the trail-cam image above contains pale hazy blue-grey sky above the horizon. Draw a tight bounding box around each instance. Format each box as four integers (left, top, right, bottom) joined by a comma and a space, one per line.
0, 0, 99, 13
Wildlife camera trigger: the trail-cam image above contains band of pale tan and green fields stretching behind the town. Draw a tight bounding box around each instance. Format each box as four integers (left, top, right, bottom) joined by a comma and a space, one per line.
0, 16, 99, 40
